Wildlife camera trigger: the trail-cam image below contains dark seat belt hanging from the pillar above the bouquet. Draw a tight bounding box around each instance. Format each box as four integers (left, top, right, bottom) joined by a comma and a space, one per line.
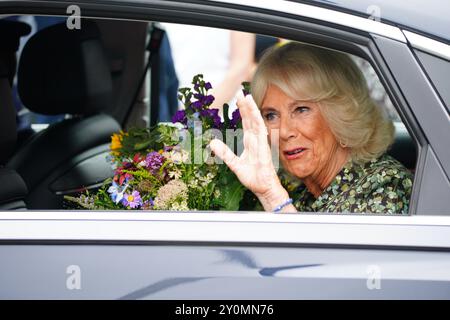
123, 23, 165, 126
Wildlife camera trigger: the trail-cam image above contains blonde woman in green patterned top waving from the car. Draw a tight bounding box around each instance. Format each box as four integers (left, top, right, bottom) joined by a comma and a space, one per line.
211, 42, 412, 214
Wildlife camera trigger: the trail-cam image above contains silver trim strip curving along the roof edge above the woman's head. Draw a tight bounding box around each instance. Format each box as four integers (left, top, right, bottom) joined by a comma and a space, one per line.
206, 0, 406, 43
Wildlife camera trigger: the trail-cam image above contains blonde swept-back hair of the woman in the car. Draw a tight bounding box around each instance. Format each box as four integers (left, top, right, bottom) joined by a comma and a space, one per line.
251, 42, 395, 163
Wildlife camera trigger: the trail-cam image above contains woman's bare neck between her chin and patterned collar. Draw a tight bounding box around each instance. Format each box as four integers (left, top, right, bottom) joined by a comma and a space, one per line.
303, 148, 350, 199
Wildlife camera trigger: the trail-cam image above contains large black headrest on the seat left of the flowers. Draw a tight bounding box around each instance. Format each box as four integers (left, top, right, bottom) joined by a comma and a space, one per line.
18, 20, 112, 115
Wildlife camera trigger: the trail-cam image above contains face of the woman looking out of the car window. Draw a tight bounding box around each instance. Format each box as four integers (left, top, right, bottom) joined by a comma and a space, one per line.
261, 85, 343, 182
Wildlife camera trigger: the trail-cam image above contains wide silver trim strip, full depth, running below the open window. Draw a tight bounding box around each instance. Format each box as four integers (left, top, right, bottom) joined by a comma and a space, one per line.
0, 211, 450, 249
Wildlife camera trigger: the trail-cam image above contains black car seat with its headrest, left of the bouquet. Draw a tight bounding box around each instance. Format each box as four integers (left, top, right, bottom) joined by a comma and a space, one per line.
7, 20, 121, 209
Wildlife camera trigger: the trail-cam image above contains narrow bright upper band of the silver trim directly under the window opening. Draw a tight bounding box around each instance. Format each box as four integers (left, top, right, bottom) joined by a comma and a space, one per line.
0, 210, 450, 226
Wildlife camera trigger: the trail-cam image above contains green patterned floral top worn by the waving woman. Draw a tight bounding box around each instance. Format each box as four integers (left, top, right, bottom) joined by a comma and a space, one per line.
281, 155, 413, 214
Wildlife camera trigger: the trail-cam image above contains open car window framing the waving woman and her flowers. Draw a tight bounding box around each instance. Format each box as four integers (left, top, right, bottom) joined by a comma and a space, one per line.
0, 17, 416, 214
